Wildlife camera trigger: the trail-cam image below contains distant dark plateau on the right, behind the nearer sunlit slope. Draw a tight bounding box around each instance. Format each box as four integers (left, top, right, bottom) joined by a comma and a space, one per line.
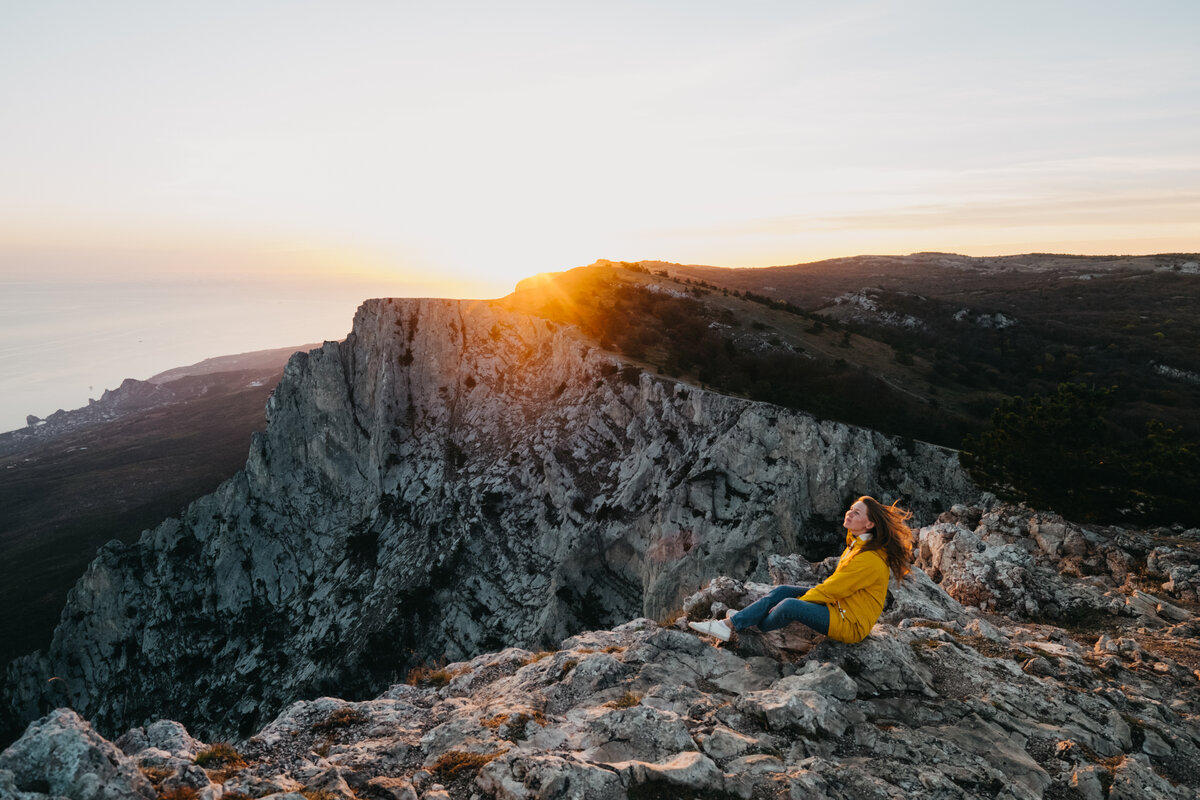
662, 253, 1200, 435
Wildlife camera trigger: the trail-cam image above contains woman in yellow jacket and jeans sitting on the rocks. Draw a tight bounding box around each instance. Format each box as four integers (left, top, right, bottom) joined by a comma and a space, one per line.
688, 497, 912, 643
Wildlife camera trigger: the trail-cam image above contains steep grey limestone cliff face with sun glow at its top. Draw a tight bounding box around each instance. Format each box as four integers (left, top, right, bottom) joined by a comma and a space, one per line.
6, 300, 973, 736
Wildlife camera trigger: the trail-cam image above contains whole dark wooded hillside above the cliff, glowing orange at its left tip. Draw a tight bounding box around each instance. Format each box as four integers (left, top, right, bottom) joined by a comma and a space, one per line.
503, 253, 1200, 524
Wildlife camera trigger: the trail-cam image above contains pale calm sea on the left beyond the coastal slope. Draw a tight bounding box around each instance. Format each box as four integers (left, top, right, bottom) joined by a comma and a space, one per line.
0, 279, 417, 431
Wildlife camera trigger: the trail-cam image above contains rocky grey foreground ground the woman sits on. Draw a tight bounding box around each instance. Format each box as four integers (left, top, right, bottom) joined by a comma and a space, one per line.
0, 506, 1200, 800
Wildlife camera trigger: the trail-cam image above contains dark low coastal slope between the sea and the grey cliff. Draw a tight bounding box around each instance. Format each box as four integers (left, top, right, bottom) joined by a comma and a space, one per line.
0, 348, 314, 663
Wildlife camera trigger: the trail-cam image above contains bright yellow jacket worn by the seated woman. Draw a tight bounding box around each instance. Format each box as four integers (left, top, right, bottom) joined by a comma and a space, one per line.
800, 534, 888, 643
